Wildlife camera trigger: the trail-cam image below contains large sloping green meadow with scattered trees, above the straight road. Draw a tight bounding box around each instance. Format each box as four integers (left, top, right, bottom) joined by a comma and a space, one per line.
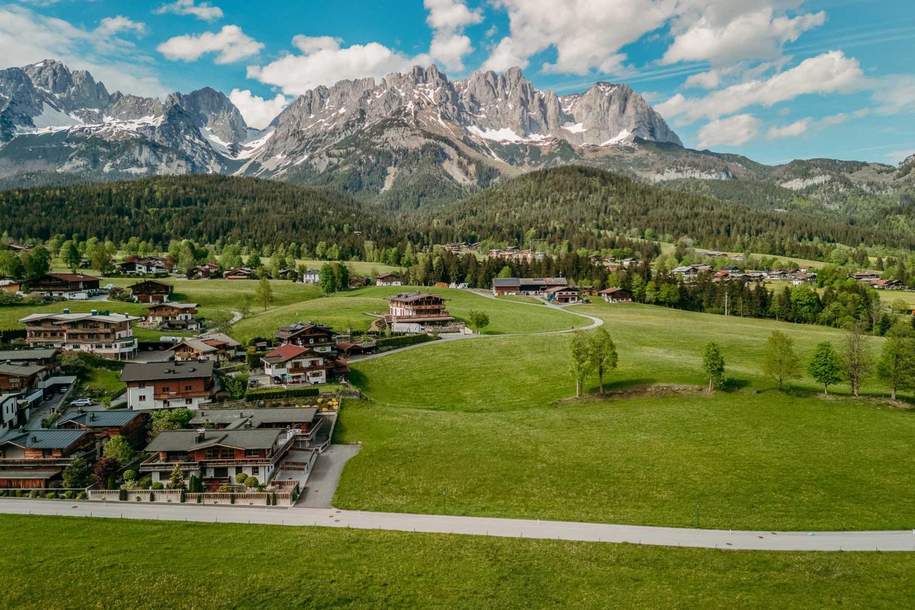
337, 304, 915, 530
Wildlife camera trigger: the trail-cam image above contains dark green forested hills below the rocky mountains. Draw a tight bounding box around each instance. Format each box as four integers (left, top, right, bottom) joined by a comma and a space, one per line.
0, 166, 915, 259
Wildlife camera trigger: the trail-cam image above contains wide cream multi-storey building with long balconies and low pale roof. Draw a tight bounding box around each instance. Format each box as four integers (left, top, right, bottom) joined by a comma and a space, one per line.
19, 310, 140, 360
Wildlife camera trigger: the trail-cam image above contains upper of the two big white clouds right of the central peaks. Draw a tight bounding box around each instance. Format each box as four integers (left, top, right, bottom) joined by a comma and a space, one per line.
662, 0, 826, 65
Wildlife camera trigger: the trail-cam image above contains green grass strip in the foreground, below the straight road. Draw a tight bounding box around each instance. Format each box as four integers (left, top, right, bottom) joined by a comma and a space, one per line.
0, 516, 915, 609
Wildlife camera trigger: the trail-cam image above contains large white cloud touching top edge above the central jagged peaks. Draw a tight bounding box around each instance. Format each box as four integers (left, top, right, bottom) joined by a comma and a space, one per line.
484, 0, 677, 75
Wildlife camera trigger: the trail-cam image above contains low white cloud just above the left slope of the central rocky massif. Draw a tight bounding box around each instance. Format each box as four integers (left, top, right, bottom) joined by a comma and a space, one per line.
248, 36, 416, 95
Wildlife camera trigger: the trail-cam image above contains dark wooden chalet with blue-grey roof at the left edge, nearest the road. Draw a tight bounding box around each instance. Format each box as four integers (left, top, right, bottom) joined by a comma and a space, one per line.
0, 429, 93, 489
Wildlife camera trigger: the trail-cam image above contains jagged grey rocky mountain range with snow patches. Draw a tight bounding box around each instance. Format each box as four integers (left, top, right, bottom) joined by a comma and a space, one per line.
0, 60, 915, 210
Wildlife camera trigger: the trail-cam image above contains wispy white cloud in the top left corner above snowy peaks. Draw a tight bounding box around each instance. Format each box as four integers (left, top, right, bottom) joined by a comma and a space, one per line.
0, 6, 168, 97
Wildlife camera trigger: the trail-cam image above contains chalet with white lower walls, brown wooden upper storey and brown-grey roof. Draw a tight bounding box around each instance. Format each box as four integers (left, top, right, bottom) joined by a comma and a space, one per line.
121, 361, 217, 411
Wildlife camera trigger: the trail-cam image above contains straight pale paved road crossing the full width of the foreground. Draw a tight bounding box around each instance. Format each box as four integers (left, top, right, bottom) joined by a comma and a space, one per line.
0, 498, 915, 552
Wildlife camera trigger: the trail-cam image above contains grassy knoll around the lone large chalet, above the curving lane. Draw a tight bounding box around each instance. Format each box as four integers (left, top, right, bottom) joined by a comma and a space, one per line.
232, 287, 588, 341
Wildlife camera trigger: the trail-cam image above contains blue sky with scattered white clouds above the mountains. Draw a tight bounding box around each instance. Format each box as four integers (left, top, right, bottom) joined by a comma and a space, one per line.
0, 0, 915, 163
